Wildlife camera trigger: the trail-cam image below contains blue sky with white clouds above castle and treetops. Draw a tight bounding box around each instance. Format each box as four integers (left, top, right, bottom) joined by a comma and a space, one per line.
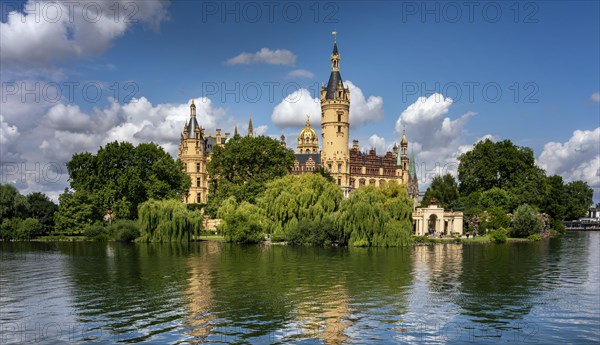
1, 1, 600, 201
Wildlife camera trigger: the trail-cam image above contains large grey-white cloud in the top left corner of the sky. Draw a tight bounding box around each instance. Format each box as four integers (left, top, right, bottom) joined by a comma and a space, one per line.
0, 0, 169, 69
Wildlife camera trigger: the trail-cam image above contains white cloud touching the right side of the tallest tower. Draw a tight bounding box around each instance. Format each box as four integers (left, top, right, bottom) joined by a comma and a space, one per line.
345, 80, 383, 128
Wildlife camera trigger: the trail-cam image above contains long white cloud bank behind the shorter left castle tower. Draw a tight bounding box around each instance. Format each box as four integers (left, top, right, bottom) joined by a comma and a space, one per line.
32, 97, 229, 161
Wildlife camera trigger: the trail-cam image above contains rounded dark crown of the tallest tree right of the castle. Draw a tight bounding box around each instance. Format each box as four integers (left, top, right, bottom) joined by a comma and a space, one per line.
458, 139, 539, 195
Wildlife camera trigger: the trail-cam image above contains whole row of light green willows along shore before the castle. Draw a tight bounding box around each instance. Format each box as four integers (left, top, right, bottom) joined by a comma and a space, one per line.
217, 174, 412, 246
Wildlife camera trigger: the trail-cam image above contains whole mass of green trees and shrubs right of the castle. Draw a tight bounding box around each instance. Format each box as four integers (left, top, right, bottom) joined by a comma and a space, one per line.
423, 139, 593, 234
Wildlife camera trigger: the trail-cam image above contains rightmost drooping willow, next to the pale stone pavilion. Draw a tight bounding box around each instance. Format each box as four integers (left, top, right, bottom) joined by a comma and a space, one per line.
335, 182, 413, 247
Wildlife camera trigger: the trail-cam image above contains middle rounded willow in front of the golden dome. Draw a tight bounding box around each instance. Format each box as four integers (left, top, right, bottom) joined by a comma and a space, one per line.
258, 174, 343, 244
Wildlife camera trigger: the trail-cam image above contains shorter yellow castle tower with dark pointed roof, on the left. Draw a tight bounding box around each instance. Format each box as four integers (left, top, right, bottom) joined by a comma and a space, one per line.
178, 100, 208, 204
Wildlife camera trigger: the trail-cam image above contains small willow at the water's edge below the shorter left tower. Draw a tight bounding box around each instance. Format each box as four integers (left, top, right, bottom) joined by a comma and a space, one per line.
138, 199, 202, 242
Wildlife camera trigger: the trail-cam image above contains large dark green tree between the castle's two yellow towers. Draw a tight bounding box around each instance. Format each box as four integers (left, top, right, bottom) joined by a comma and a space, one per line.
206, 136, 295, 216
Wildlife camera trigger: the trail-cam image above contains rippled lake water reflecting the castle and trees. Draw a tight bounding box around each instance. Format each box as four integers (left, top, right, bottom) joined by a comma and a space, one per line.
0, 232, 600, 344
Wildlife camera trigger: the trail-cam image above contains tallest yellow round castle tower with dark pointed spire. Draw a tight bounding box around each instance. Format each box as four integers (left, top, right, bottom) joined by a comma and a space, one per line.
321, 32, 350, 195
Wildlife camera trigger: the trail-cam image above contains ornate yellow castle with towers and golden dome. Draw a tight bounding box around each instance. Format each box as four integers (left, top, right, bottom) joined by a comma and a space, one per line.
179, 39, 419, 203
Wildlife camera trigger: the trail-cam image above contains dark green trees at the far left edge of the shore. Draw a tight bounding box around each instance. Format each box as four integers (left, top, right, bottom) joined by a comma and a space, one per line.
0, 184, 58, 241
